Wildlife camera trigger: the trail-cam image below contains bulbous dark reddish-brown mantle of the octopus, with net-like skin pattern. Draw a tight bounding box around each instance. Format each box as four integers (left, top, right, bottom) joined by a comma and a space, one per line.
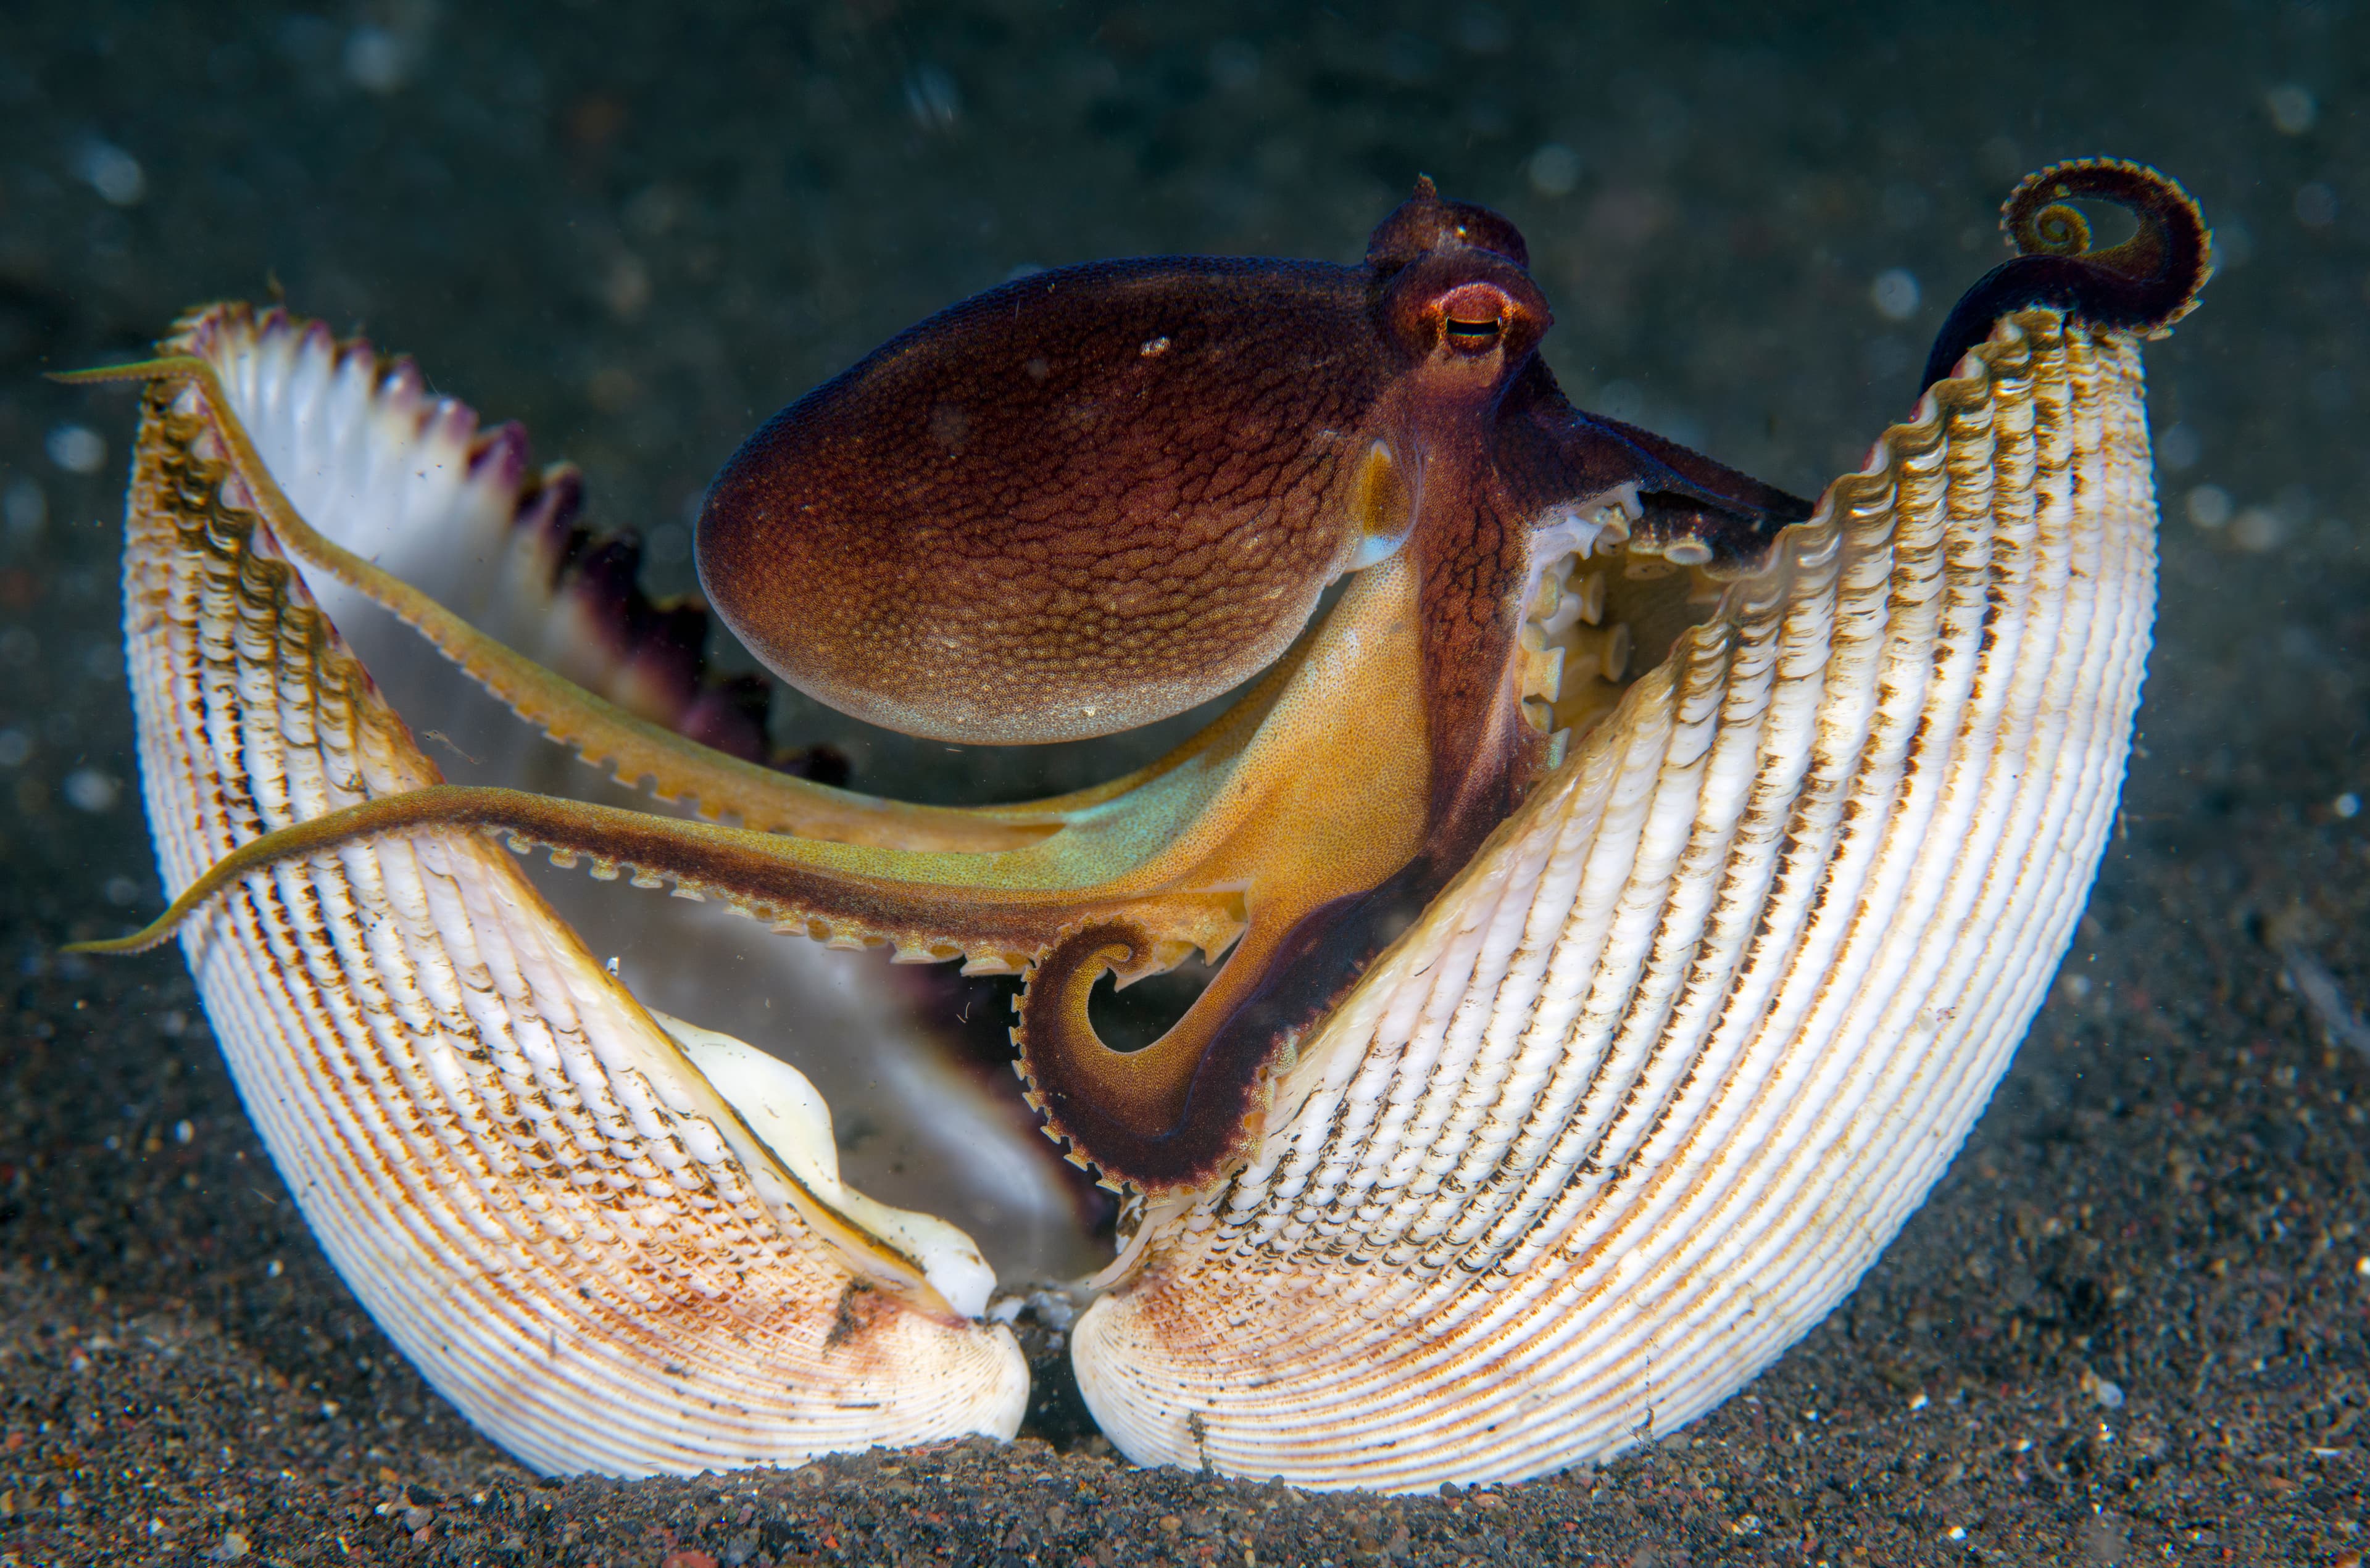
699, 258, 1382, 741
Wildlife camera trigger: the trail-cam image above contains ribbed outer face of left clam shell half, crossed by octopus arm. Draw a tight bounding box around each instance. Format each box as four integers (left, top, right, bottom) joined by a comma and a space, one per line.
123, 341, 1029, 1475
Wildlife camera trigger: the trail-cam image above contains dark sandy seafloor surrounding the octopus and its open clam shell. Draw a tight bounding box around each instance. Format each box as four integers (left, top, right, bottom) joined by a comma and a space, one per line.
0, 0, 2370, 1568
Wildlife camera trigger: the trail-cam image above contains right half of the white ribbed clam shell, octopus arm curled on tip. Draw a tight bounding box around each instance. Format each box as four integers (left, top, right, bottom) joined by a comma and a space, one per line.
1074, 310, 2156, 1490
